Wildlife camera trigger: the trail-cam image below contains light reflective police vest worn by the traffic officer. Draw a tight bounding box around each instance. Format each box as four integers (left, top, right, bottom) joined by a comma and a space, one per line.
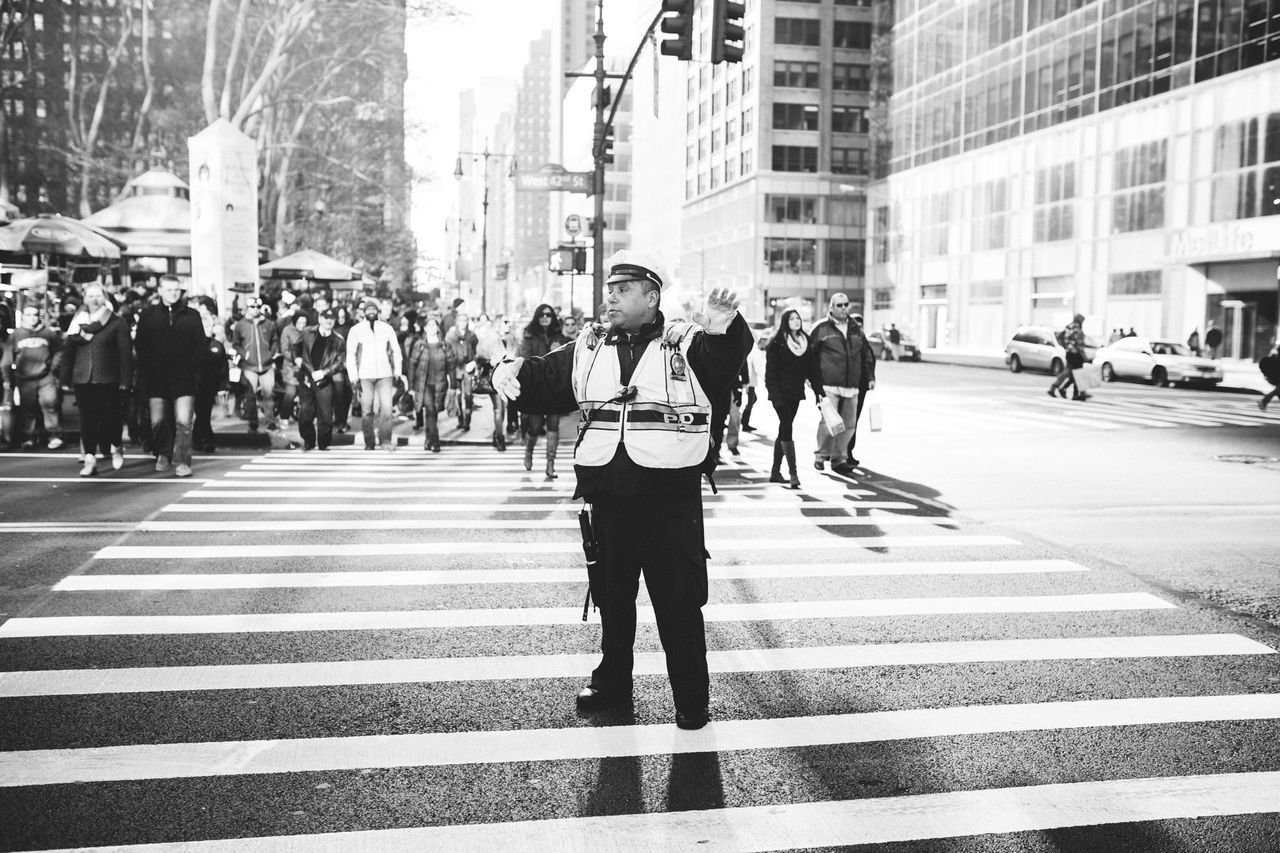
573, 321, 712, 469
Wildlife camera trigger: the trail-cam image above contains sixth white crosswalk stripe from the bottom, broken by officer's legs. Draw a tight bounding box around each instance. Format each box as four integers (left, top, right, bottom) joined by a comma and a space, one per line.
93, 533, 1020, 560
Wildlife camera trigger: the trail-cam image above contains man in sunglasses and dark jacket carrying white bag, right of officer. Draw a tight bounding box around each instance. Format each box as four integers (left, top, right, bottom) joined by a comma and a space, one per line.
808, 293, 876, 476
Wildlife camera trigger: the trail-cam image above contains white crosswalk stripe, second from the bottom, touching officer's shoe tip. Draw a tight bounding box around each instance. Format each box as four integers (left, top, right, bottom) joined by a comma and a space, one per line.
0, 693, 1280, 783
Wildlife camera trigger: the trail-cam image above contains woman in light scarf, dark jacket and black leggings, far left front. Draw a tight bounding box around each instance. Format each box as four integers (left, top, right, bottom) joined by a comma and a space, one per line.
63, 282, 133, 476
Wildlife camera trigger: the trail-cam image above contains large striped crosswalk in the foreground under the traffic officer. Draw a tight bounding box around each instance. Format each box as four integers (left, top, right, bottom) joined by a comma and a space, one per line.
0, 447, 1280, 853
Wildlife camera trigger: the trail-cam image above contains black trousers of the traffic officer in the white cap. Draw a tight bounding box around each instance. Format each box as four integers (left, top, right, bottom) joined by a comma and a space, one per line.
591, 494, 710, 713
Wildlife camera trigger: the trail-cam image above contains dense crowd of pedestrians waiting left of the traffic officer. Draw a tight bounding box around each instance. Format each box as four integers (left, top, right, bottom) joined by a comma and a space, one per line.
0, 275, 580, 479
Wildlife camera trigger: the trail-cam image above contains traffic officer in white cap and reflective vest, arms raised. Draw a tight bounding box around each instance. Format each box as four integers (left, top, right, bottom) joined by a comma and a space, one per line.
493, 250, 751, 729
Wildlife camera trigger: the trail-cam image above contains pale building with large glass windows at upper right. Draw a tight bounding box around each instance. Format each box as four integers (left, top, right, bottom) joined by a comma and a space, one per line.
868, 0, 1280, 360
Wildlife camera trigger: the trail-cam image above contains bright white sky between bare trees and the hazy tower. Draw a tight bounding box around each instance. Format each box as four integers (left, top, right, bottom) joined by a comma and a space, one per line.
404, 0, 559, 279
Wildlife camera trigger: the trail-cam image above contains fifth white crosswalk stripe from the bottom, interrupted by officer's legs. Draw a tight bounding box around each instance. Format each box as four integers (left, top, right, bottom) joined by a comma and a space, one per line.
52, 560, 1088, 592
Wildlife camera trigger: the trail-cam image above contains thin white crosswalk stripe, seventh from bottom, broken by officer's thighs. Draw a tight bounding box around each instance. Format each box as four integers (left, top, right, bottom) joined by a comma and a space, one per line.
135, 506, 955, 532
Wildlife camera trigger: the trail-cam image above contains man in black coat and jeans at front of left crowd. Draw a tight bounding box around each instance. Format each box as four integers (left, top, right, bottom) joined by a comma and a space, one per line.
134, 275, 206, 476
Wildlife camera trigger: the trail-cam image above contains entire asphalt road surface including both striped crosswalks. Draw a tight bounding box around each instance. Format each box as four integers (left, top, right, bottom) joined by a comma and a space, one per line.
0, 365, 1280, 853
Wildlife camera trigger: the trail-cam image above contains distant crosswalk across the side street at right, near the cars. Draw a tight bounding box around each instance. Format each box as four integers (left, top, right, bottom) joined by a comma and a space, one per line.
877, 386, 1280, 435
